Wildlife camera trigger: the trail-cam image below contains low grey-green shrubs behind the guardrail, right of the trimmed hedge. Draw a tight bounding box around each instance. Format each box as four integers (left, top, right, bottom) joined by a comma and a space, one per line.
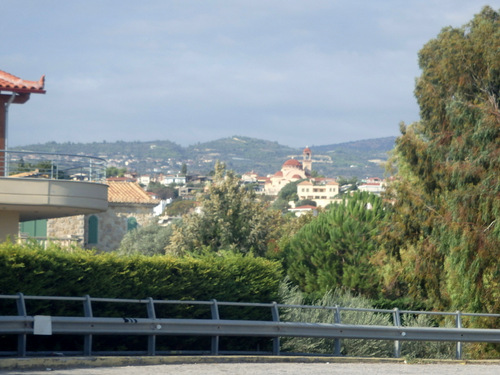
280, 281, 456, 359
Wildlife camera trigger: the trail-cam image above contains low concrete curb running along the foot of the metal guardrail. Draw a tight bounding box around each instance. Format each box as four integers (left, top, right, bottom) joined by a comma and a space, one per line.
0, 355, 500, 371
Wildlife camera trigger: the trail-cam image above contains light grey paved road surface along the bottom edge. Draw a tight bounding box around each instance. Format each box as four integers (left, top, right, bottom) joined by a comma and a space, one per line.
0, 363, 500, 375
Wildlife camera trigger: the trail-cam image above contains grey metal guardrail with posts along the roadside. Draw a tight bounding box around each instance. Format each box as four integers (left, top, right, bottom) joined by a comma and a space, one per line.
0, 293, 500, 359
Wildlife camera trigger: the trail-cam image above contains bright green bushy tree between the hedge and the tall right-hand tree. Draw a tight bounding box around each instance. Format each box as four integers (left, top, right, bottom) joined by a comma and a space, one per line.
284, 192, 389, 297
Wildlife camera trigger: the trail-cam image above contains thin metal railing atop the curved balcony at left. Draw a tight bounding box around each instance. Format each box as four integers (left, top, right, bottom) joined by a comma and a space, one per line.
0, 150, 106, 183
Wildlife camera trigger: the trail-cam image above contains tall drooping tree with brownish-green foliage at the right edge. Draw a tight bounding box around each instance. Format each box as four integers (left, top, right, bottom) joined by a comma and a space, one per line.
381, 7, 500, 312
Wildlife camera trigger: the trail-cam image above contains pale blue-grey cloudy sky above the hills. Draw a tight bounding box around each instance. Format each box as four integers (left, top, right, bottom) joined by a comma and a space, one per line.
0, 0, 500, 147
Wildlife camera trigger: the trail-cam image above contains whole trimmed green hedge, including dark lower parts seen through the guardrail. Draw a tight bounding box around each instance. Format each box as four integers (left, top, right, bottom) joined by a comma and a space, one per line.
0, 242, 282, 351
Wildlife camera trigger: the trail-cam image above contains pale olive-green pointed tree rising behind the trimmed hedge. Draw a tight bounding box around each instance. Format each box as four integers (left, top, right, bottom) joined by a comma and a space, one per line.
168, 162, 282, 255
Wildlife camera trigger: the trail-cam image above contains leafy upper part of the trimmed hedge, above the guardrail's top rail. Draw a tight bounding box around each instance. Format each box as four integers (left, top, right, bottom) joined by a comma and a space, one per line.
0, 243, 282, 315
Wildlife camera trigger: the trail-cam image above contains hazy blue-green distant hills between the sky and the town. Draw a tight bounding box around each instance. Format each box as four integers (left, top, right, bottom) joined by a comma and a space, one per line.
15, 136, 396, 178
